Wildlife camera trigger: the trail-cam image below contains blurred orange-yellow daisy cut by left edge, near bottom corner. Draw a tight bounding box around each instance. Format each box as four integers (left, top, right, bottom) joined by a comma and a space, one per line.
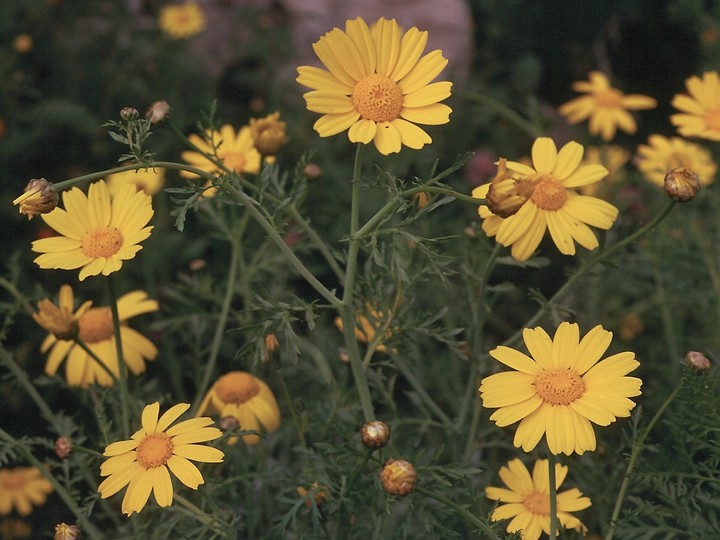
0, 467, 53, 516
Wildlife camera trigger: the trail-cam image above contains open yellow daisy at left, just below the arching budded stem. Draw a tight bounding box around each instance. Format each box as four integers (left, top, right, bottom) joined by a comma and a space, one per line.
32, 180, 153, 281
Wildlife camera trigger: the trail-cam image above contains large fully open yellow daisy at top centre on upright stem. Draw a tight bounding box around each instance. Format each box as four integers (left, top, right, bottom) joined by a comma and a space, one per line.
297, 17, 452, 154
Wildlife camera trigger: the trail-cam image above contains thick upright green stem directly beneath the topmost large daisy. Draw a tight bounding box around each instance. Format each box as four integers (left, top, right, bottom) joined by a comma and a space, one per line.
339, 143, 375, 422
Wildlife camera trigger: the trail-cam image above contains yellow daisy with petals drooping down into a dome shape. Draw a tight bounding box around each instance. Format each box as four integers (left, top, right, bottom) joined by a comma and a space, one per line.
198, 371, 280, 445
